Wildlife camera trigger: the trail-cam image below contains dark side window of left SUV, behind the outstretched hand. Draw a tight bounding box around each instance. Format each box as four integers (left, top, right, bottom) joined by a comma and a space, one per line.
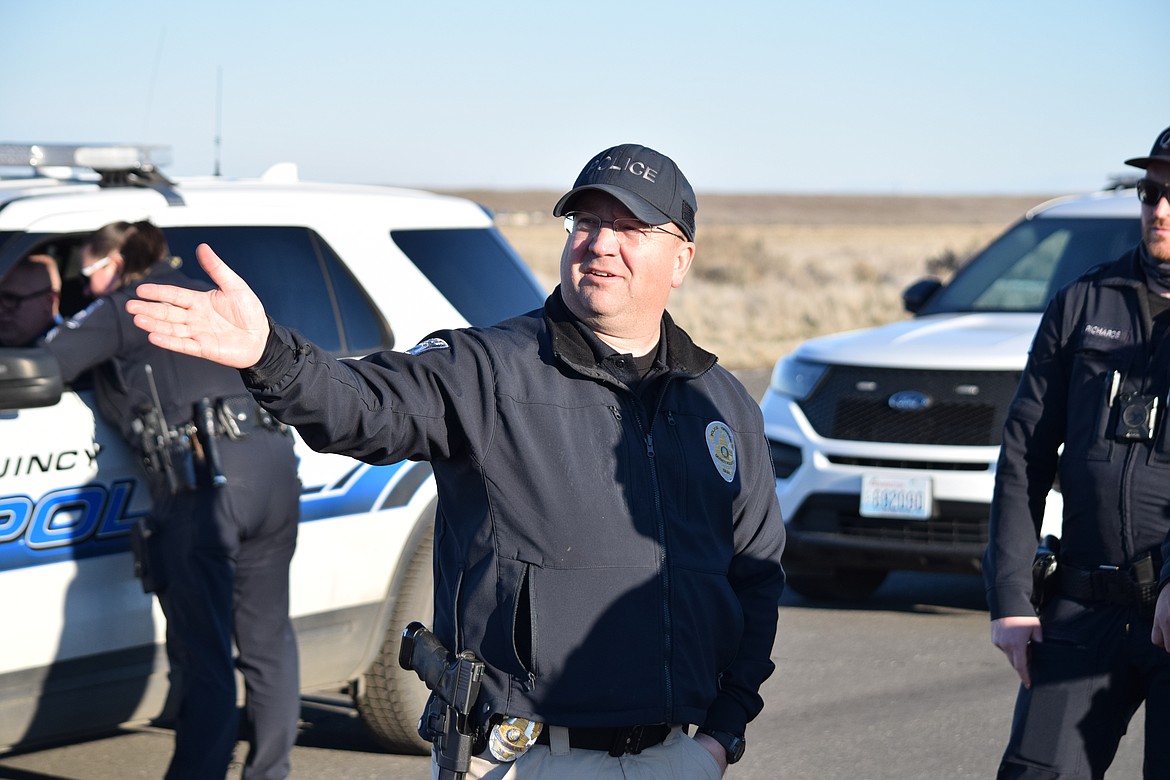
164, 227, 393, 354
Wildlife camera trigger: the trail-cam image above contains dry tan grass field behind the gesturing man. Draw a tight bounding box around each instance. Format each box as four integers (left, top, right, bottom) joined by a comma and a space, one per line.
442, 191, 1045, 370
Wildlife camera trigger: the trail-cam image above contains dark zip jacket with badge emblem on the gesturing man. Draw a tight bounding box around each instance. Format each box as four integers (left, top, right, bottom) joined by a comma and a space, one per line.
246, 291, 784, 733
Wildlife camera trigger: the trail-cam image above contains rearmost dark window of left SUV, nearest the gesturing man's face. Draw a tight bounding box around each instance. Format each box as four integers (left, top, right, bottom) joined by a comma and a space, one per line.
390, 228, 545, 326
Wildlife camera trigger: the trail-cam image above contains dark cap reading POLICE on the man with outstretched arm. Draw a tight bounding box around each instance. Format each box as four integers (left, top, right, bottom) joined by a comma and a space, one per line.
552, 144, 698, 241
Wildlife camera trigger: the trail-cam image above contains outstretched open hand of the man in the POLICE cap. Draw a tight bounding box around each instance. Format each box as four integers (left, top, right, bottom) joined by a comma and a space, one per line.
126, 243, 269, 368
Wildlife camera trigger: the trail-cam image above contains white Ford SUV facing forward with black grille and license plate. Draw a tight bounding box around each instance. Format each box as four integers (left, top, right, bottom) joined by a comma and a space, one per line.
762, 185, 1141, 599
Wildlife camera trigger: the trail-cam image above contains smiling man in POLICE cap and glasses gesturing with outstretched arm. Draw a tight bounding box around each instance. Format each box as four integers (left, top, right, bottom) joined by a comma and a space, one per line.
128, 144, 784, 779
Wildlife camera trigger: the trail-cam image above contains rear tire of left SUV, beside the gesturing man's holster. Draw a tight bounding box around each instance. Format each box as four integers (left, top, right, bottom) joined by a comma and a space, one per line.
355, 505, 434, 755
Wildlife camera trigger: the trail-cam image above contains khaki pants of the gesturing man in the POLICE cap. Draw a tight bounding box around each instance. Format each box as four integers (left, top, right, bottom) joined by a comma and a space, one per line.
431, 726, 721, 780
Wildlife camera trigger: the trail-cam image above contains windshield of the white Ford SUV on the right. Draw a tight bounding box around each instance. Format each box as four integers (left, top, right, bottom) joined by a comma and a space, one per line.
918, 218, 1141, 316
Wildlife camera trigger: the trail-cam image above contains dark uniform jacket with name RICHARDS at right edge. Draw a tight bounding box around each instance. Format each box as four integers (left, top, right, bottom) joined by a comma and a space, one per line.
984, 247, 1170, 619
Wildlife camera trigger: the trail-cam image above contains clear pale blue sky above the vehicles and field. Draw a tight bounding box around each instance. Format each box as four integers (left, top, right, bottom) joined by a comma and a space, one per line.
0, 0, 1170, 194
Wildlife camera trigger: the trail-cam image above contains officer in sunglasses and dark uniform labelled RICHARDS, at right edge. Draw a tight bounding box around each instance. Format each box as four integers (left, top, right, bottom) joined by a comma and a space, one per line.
985, 129, 1170, 779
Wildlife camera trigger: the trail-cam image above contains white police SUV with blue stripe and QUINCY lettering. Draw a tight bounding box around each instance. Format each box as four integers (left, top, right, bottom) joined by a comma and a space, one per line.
0, 144, 545, 752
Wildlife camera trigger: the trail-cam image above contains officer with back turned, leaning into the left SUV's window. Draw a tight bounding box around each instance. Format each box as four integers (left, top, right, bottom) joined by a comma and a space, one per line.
46, 221, 300, 780
